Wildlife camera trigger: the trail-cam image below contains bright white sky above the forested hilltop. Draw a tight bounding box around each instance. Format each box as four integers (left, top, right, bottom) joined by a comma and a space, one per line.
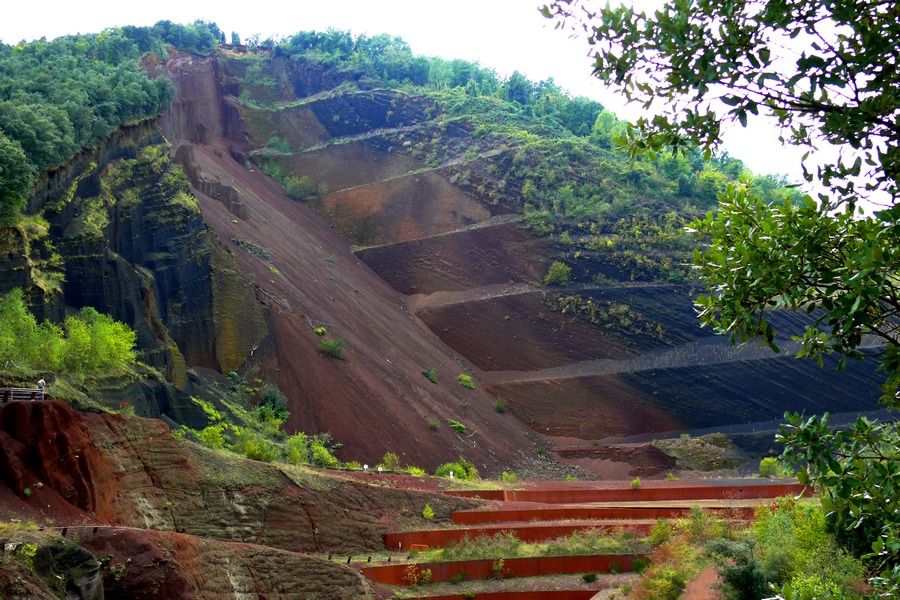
0, 0, 801, 179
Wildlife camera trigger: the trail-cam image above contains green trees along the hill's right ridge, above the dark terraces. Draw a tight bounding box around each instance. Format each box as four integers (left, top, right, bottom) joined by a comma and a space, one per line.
264, 30, 796, 218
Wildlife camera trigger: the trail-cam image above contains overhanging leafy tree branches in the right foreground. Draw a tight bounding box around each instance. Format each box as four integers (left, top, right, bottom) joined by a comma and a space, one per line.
542, 0, 900, 597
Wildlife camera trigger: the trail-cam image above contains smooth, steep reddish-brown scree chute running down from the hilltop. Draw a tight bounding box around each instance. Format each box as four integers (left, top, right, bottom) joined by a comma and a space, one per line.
156, 51, 531, 473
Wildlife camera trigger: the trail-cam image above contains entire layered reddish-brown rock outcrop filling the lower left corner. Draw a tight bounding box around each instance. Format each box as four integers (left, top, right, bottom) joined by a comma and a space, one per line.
0, 401, 470, 599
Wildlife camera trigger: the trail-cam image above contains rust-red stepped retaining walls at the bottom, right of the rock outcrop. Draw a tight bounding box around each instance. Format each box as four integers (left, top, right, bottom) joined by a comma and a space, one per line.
362, 480, 809, 600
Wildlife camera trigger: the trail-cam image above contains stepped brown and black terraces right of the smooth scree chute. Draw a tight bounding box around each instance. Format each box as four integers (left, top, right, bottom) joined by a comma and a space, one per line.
220, 58, 877, 473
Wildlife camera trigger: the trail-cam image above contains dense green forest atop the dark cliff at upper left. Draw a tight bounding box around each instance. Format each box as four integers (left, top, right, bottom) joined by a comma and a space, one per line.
0, 21, 224, 221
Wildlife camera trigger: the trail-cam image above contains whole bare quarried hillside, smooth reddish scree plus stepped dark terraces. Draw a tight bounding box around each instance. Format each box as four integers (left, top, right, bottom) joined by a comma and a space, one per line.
158, 50, 876, 476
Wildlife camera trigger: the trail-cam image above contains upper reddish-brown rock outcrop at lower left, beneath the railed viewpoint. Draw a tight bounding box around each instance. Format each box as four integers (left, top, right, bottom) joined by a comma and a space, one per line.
0, 401, 469, 553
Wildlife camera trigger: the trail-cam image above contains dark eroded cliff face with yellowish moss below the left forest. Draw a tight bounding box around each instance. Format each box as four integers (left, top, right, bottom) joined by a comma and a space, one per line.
13, 117, 264, 398
